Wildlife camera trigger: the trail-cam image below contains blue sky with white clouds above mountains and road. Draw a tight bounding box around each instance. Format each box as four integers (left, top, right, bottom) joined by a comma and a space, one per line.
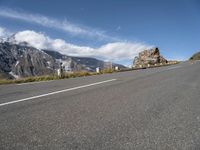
0, 0, 200, 65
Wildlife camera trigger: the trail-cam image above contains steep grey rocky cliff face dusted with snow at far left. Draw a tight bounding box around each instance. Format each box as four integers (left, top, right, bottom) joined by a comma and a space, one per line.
0, 42, 57, 78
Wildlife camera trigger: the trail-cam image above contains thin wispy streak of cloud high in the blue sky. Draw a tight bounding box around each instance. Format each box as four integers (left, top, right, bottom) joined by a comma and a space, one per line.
0, 7, 118, 41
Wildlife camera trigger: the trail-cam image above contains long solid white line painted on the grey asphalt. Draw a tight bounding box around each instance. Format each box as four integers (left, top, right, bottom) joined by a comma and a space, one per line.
0, 79, 117, 107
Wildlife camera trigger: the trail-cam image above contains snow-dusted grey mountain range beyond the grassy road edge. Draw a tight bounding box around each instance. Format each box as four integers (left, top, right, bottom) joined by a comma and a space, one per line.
0, 40, 124, 78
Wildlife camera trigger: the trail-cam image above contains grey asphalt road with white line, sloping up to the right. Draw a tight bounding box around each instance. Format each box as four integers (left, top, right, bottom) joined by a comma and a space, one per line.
0, 61, 200, 150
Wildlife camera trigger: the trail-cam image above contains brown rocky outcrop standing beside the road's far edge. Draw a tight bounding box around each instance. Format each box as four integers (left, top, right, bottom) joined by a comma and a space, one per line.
133, 48, 167, 68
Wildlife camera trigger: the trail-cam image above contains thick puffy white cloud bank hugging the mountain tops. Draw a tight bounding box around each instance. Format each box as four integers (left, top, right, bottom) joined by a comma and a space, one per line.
15, 30, 152, 62
